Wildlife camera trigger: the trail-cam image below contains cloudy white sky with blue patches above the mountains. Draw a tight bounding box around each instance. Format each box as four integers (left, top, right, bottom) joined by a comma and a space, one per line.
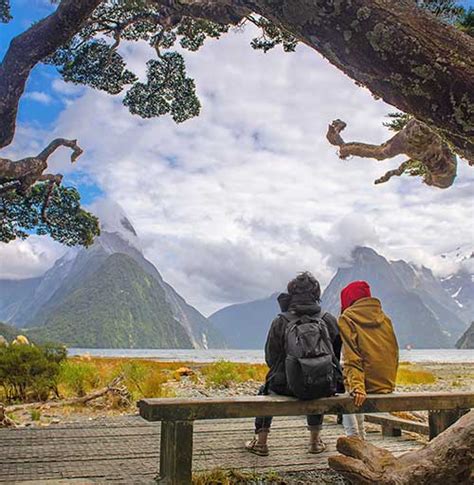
0, 0, 474, 314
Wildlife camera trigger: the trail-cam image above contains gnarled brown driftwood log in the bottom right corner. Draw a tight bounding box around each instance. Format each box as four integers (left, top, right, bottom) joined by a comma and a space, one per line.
329, 411, 474, 485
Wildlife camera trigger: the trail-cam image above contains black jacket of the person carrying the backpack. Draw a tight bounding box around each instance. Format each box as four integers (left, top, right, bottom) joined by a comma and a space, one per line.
265, 293, 344, 396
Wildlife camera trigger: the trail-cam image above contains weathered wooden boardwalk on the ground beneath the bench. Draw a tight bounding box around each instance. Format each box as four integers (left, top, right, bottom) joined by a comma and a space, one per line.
0, 416, 422, 485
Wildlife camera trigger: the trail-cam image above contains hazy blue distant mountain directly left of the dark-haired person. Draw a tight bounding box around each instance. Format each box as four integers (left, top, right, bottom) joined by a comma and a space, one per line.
209, 293, 280, 349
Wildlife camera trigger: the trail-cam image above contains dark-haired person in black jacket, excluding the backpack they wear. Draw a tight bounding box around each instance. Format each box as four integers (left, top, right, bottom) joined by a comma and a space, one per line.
245, 272, 344, 456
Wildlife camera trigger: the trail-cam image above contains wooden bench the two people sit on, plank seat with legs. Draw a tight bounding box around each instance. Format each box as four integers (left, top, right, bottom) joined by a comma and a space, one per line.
138, 392, 474, 485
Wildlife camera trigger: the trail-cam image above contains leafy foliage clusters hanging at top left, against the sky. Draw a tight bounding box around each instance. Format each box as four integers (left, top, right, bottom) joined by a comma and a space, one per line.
44, 0, 229, 123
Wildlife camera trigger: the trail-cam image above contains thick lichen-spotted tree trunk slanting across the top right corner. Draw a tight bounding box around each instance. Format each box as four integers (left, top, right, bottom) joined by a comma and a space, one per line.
248, 0, 474, 163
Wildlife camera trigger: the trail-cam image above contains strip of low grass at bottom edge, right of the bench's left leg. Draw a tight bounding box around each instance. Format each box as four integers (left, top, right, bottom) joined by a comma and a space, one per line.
193, 468, 285, 485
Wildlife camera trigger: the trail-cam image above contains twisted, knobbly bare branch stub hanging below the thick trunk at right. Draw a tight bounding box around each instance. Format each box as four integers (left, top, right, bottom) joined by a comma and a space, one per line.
326, 119, 457, 189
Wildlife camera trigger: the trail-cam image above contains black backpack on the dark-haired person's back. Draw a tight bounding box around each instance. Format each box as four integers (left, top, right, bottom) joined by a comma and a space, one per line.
281, 312, 342, 399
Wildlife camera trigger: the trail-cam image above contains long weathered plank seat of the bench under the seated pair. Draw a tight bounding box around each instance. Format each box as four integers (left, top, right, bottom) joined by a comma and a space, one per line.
138, 392, 474, 421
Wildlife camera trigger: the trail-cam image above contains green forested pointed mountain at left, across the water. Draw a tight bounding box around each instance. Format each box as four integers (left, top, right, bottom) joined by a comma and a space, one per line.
28, 253, 192, 348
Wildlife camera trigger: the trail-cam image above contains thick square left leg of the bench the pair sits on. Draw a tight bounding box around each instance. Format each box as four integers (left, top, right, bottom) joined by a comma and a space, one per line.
159, 421, 193, 485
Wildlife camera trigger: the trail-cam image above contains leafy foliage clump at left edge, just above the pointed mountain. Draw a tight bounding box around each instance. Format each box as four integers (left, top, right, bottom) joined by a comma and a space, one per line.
0, 183, 100, 246
